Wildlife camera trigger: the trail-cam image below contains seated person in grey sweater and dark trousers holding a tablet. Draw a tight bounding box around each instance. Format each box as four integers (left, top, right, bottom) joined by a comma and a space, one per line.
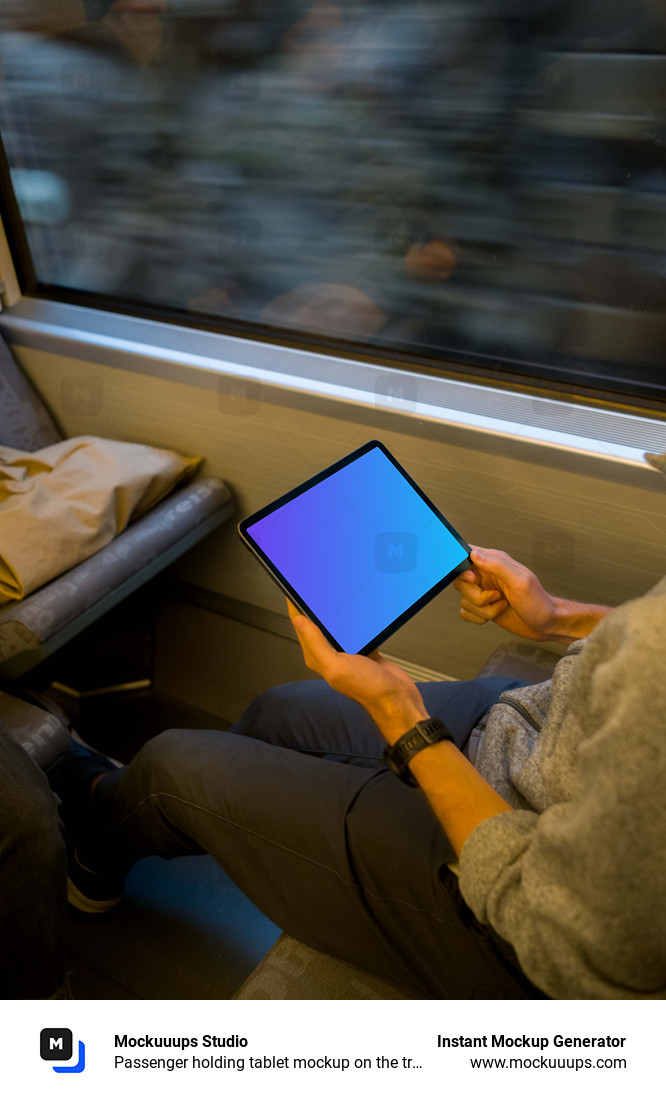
53, 536, 666, 999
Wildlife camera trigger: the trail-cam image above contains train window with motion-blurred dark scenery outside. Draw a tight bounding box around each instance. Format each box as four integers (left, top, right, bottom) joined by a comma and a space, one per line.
0, 0, 666, 399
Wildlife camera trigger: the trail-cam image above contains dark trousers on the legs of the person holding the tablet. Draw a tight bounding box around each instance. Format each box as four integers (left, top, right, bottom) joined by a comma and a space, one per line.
98, 678, 539, 998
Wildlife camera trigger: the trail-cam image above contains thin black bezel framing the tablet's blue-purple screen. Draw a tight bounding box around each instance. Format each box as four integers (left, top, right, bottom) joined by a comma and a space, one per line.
238, 439, 471, 656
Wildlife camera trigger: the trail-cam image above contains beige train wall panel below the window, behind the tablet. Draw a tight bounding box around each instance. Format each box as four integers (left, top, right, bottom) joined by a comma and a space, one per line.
13, 347, 666, 722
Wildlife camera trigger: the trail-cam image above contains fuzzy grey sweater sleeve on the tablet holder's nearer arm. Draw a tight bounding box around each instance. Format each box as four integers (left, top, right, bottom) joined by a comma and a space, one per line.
460, 590, 666, 999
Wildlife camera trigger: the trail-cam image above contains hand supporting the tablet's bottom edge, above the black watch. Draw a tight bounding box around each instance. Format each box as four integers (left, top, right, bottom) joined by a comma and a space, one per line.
287, 600, 428, 745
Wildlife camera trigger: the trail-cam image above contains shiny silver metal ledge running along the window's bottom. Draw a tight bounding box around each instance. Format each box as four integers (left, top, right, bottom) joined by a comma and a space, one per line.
0, 297, 666, 488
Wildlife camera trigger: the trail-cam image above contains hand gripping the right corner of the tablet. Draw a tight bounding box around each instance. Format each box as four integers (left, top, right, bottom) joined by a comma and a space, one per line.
454, 547, 558, 641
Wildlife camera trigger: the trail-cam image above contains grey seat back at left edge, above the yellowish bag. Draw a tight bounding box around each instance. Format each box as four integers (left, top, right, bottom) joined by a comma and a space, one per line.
0, 337, 63, 451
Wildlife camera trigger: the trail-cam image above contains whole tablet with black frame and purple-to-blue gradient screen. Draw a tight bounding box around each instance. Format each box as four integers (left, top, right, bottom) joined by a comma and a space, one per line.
239, 440, 470, 653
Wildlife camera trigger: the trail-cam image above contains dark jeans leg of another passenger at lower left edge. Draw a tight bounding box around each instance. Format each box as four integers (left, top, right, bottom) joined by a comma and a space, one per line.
0, 734, 67, 999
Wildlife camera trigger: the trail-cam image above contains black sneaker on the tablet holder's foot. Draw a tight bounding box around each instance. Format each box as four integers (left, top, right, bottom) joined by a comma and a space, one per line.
48, 740, 124, 914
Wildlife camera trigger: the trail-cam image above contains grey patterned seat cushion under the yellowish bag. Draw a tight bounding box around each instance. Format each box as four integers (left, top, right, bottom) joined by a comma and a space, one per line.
0, 477, 232, 679
